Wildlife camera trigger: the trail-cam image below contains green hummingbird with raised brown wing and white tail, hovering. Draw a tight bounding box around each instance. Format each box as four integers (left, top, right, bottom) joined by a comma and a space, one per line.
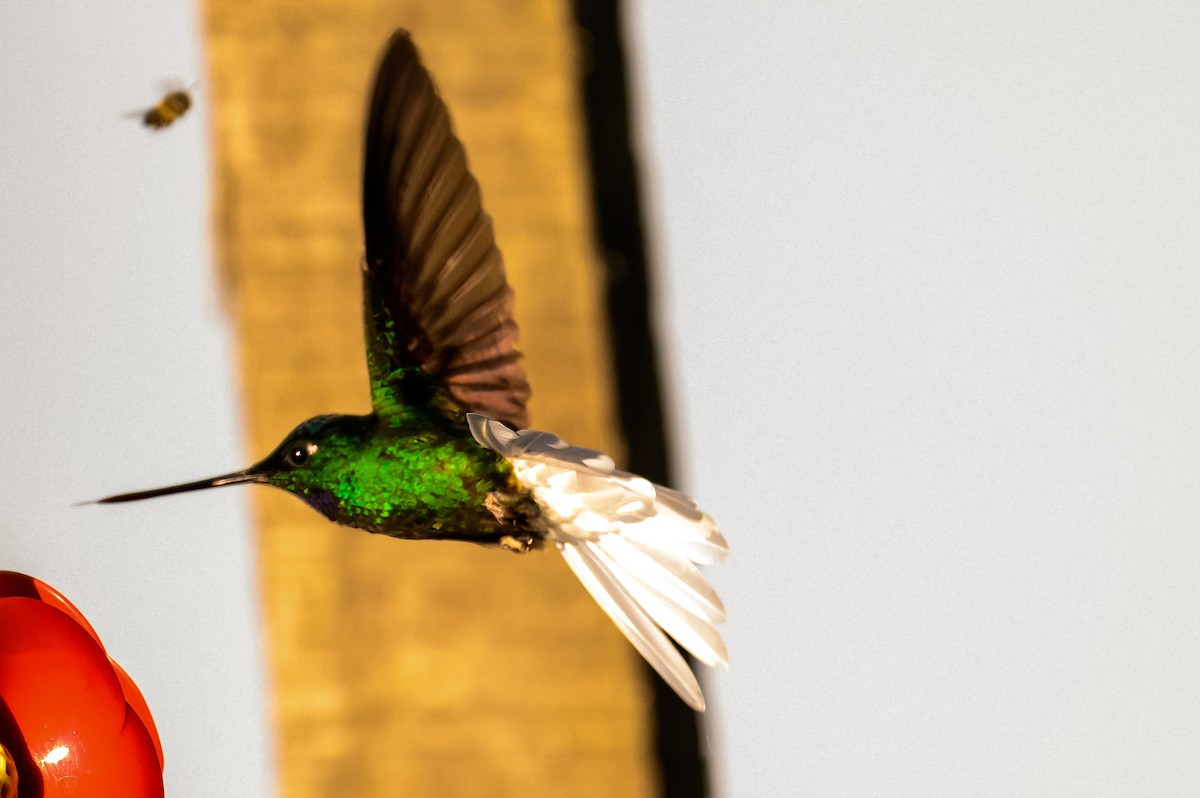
93, 31, 728, 710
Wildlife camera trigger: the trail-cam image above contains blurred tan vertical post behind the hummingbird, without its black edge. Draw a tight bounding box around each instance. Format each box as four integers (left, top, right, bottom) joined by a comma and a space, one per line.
202, 0, 656, 797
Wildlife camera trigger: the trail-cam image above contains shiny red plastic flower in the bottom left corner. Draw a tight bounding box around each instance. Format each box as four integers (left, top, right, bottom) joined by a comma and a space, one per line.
0, 571, 163, 798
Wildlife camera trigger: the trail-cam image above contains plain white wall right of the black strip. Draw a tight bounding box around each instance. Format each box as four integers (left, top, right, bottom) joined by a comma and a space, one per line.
628, 0, 1200, 797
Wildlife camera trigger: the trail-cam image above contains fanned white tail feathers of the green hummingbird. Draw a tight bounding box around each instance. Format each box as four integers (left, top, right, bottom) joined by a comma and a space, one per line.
467, 413, 730, 712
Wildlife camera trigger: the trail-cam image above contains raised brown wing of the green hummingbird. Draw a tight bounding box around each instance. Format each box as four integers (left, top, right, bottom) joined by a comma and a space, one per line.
362, 31, 529, 427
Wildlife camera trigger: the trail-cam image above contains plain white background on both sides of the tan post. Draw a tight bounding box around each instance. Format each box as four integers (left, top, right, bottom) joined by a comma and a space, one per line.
0, 0, 1200, 797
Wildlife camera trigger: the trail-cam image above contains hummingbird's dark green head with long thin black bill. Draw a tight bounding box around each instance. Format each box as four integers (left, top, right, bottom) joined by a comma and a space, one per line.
97, 415, 376, 518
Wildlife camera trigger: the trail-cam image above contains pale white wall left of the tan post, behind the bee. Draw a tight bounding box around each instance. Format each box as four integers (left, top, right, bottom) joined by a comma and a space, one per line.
0, 0, 274, 798
